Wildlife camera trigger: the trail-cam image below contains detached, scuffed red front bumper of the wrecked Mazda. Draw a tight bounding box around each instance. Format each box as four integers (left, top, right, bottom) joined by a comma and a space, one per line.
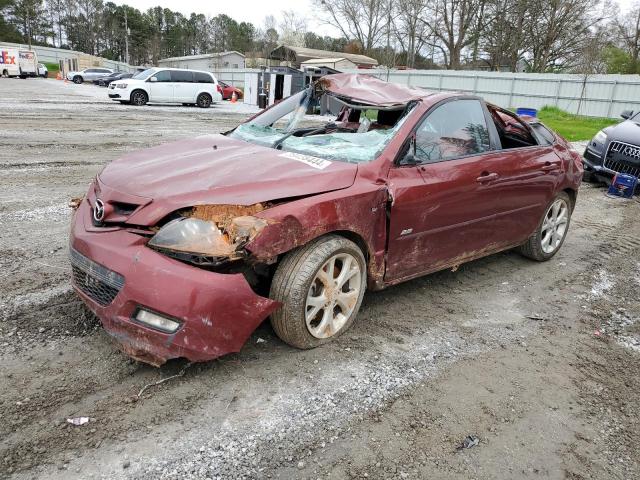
70, 199, 280, 366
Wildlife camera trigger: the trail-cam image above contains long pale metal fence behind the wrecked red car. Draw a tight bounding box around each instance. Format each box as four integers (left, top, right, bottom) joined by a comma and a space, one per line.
214, 69, 640, 118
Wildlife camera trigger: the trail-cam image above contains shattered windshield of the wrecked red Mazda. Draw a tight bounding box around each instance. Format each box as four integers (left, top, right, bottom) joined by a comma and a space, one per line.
229, 87, 411, 163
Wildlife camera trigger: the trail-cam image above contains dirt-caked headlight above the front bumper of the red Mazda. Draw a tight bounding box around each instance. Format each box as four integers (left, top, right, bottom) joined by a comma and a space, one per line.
149, 216, 267, 258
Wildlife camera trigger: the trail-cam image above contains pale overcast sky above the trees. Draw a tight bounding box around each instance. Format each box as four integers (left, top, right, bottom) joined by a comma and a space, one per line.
115, 0, 638, 37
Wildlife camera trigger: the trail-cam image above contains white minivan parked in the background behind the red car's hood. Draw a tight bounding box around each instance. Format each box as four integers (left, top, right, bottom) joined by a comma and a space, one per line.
108, 68, 222, 108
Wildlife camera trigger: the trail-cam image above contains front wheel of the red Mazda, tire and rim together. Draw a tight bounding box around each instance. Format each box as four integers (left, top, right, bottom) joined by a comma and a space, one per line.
270, 235, 367, 349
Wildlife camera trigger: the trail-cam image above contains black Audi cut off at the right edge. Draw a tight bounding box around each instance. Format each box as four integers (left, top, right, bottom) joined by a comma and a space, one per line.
583, 110, 640, 183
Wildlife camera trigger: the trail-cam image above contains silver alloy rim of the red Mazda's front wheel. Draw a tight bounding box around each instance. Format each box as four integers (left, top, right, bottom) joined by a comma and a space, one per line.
304, 253, 362, 338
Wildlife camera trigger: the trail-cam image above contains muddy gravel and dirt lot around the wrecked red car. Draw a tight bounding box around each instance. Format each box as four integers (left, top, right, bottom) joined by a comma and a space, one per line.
0, 79, 640, 479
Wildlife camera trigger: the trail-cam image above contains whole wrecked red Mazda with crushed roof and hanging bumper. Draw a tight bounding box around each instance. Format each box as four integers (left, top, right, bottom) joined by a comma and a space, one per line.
70, 74, 582, 365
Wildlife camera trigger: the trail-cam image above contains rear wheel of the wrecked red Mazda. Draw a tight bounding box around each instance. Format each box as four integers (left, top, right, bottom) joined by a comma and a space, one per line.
518, 192, 574, 262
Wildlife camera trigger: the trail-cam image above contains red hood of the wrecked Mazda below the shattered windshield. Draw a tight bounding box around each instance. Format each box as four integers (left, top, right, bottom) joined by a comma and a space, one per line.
96, 135, 358, 225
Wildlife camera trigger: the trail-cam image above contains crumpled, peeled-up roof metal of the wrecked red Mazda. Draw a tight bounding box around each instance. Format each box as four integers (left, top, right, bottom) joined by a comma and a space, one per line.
318, 73, 433, 107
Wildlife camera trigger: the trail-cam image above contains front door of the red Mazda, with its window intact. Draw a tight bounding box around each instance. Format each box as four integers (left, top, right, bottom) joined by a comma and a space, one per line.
386, 98, 500, 281
